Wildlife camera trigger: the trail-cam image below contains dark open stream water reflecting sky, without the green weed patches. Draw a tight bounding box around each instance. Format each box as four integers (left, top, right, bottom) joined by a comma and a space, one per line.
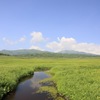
4, 72, 52, 100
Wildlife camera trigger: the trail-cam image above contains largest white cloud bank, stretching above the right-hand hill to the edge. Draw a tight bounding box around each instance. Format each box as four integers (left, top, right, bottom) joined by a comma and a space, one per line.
46, 37, 100, 54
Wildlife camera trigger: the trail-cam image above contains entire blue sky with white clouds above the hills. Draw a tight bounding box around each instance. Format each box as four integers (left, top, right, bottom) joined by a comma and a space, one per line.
0, 0, 100, 54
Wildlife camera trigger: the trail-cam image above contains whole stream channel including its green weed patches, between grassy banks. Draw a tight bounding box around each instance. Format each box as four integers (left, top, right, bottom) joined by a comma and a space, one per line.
3, 72, 65, 100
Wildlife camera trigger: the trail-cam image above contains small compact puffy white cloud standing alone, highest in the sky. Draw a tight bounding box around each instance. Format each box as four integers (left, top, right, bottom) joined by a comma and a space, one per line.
31, 32, 45, 43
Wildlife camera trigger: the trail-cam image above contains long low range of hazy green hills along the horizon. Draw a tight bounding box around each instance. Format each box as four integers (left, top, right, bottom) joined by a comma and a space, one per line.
0, 49, 98, 58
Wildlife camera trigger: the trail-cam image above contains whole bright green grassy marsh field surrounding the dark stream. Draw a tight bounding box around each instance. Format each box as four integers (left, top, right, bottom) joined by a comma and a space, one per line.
0, 56, 100, 100
